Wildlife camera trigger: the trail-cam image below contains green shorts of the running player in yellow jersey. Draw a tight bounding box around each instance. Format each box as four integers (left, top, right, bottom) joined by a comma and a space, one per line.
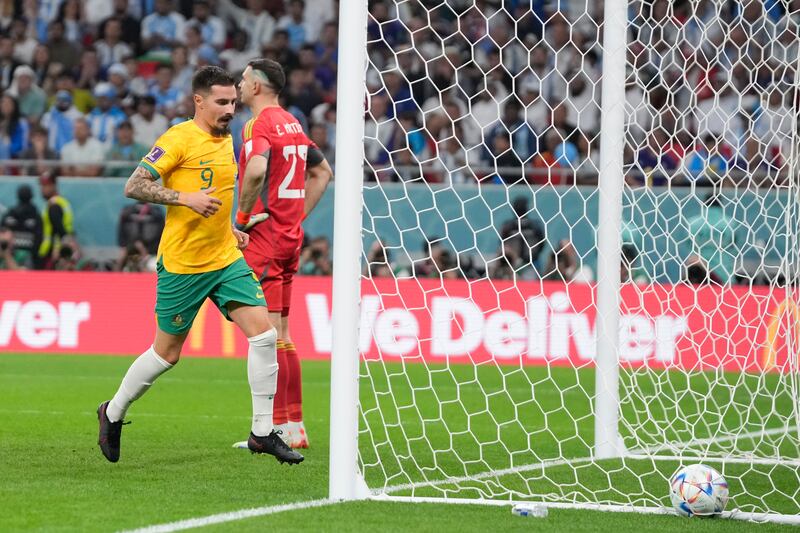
156, 258, 266, 335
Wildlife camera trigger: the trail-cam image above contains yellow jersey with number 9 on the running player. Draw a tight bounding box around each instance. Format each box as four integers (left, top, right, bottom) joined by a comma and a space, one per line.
139, 120, 242, 274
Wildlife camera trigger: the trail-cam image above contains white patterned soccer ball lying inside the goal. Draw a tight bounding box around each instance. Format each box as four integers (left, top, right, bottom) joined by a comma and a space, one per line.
669, 464, 728, 516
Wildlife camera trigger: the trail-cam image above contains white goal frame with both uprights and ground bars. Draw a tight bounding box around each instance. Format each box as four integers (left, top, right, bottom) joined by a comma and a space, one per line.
329, 0, 800, 524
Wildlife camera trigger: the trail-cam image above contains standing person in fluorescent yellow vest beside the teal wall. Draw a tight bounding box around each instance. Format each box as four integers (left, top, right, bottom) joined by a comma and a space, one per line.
37, 171, 74, 268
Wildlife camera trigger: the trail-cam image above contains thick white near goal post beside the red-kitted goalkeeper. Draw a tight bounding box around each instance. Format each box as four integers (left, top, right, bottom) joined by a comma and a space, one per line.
328, 0, 367, 500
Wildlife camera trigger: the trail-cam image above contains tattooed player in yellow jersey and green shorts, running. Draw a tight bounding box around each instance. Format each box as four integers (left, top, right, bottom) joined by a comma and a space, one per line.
97, 67, 303, 464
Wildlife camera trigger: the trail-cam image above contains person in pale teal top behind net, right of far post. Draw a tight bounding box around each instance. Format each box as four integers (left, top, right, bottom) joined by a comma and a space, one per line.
687, 192, 740, 283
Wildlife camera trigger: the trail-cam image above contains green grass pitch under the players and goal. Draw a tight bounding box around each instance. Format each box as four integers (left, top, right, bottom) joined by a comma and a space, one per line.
0, 354, 799, 532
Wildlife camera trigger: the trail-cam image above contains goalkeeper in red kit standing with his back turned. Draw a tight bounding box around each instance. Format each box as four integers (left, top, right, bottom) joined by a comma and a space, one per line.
236, 59, 333, 448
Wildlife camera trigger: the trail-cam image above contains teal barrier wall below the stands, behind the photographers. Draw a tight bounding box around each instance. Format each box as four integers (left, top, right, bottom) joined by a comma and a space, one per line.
0, 176, 791, 283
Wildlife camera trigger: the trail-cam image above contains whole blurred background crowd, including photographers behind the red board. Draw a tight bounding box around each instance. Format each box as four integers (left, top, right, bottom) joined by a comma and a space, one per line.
0, 0, 800, 279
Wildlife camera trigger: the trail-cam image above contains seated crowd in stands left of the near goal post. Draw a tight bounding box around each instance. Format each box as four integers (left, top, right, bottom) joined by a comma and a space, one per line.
0, 0, 338, 176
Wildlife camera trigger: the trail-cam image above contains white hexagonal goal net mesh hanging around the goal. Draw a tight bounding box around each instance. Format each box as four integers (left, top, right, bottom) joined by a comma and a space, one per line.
359, 0, 800, 514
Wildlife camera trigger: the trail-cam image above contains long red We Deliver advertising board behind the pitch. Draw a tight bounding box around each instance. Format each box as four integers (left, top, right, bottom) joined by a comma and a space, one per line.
0, 272, 800, 372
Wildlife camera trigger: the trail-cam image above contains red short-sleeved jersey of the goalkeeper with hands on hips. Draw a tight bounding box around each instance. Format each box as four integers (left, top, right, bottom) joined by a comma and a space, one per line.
239, 107, 319, 262
